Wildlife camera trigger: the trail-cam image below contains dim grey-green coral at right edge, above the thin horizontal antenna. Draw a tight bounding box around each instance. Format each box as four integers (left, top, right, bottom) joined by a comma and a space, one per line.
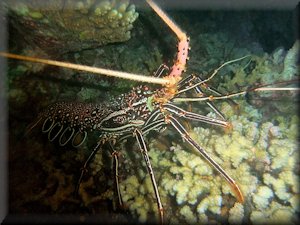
213, 40, 299, 99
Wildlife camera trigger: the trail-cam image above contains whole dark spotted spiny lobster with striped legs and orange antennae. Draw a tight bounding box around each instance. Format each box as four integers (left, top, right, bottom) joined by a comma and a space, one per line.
1, 0, 298, 223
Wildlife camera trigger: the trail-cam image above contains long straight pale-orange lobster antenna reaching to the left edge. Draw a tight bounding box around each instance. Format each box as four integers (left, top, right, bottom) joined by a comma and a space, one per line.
0, 52, 169, 85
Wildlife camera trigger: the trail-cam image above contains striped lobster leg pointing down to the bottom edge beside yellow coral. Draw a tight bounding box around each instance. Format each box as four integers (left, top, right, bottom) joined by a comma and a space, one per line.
134, 129, 164, 224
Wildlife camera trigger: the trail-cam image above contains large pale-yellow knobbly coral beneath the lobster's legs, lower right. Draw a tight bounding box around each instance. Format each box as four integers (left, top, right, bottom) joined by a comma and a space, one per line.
115, 64, 299, 224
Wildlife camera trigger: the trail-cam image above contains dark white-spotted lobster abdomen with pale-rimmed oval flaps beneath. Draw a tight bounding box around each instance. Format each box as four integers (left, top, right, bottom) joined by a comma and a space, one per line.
38, 102, 112, 147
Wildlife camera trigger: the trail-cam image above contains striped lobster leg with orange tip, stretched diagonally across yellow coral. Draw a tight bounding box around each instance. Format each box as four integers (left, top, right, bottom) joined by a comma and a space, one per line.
166, 115, 244, 203
